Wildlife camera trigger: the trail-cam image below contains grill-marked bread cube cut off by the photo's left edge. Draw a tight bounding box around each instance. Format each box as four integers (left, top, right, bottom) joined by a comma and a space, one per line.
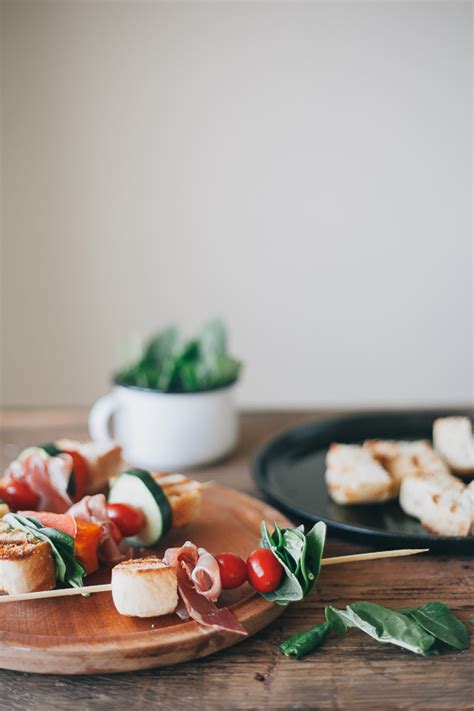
0, 521, 56, 595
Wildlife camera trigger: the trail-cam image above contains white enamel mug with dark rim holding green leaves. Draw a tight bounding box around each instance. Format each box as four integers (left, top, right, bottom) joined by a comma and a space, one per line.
89, 383, 239, 471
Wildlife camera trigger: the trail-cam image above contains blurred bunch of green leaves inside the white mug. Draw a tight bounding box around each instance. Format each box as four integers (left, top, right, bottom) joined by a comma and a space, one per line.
115, 319, 241, 393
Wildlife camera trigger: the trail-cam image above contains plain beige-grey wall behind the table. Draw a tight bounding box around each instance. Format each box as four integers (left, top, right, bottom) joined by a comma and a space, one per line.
1, 0, 473, 407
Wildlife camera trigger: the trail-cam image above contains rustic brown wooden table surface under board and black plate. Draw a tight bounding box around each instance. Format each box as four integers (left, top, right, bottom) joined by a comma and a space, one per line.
0, 410, 474, 711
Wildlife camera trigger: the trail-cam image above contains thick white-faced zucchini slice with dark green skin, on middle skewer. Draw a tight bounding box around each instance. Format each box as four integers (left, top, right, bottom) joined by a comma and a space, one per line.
109, 469, 173, 548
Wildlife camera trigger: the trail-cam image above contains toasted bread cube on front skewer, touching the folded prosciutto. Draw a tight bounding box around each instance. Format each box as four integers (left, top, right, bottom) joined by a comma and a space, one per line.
112, 556, 178, 617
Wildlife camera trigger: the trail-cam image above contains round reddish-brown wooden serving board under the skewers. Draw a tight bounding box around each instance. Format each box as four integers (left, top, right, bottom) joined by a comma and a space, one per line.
0, 485, 291, 674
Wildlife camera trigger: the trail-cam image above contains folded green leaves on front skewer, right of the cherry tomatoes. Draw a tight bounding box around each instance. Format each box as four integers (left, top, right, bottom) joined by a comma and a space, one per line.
260, 521, 326, 605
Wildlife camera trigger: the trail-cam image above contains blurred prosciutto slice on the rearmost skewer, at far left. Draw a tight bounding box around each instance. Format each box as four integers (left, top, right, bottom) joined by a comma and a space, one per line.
5, 452, 73, 513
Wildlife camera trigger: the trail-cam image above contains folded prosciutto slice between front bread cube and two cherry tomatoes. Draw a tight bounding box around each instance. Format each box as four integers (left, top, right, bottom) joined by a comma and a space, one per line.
163, 541, 247, 635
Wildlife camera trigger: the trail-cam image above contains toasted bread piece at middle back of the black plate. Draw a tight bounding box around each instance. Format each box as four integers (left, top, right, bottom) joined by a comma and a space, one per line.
364, 439, 449, 493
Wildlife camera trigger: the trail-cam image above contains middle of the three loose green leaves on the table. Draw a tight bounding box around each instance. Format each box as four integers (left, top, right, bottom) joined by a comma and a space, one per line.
326, 602, 436, 655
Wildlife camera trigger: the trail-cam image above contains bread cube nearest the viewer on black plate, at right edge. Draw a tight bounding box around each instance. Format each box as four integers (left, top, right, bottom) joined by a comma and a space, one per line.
421, 487, 472, 536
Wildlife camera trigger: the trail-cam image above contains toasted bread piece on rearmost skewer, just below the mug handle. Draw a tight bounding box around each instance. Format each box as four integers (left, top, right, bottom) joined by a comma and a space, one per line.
56, 439, 123, 493
